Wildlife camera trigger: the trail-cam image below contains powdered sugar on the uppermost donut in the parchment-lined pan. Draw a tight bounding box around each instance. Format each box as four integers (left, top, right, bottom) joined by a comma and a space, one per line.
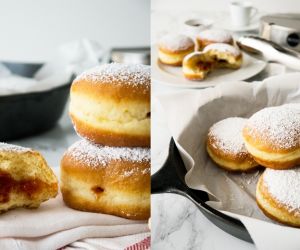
246, 106, 300, 149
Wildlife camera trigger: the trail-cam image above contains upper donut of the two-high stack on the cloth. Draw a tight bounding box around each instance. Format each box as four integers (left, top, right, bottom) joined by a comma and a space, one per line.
69, 63, 150, 147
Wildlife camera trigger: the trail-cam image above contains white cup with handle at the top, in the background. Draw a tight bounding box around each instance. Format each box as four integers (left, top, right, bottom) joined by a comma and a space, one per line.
229, 1, 258, 27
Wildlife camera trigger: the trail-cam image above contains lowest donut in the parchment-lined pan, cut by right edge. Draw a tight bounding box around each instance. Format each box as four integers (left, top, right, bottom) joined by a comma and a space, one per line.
256, 168, 300, 227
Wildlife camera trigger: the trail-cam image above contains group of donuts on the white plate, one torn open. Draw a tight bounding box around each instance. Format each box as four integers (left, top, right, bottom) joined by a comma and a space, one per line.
158, 29, 243, 80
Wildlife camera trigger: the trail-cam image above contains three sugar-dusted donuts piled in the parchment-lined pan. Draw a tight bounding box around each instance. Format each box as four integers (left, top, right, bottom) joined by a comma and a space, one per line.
207, 104, 300, 227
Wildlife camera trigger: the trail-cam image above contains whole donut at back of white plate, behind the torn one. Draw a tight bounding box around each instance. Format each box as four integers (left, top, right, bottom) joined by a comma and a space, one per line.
196, 29, 233, 51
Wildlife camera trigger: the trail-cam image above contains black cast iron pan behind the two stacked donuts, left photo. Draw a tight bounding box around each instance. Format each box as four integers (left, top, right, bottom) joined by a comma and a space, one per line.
0, 63, 71, 141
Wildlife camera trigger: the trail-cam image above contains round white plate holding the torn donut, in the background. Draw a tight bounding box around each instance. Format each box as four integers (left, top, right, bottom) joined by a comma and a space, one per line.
151, 47, 267, 88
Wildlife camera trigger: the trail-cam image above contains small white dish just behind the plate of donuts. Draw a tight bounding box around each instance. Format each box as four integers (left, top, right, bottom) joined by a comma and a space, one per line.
184, 18, 213, 38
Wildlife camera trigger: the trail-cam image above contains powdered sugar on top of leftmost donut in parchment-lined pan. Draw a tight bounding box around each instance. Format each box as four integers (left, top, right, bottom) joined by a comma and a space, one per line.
208, 117, 248, 154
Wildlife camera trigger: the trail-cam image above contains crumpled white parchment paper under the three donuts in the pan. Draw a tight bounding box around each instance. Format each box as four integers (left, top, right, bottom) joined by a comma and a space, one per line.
159, 73, 300, 249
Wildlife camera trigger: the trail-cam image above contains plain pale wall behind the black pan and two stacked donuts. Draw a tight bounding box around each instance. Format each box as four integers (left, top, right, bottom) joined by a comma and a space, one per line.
0, 0, 150, 61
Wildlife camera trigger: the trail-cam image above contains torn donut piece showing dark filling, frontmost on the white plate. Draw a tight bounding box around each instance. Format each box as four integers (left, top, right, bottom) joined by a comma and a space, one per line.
182, 52, 215, 80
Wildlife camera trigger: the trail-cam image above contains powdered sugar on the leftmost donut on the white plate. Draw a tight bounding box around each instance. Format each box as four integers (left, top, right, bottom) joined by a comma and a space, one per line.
158, 34, 195, 52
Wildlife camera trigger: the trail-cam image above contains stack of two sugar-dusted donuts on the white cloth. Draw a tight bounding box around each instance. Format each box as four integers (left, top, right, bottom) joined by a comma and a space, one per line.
61, 63, 150, 220
